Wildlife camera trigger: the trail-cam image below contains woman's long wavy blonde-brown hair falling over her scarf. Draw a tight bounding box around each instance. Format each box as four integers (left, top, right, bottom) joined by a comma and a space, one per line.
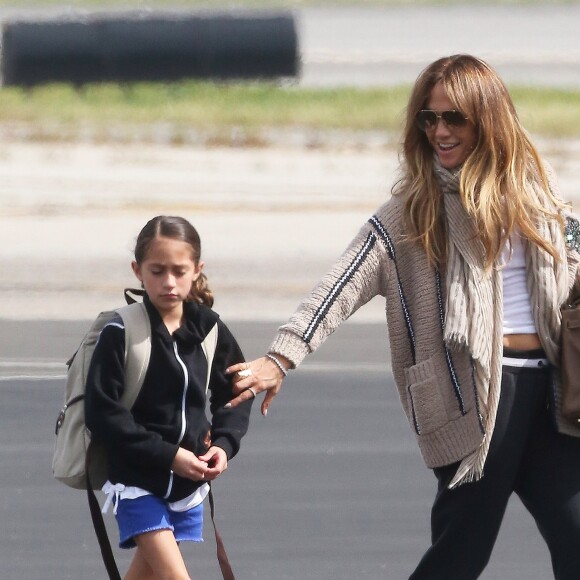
393, 55, 564, 268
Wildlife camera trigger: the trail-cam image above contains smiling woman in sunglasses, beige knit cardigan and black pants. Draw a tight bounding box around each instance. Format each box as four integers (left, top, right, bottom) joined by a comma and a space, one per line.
229, 55, 580, 580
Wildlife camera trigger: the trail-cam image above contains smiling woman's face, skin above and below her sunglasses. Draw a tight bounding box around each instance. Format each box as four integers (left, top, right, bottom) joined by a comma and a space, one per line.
425, 82, 477, 169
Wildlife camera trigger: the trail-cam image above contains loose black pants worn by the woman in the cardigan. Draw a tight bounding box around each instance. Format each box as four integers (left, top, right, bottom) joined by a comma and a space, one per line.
410, 360, 580, 580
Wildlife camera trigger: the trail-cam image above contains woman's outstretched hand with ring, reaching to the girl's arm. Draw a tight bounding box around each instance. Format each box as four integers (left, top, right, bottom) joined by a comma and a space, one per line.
226, 355, 291, 417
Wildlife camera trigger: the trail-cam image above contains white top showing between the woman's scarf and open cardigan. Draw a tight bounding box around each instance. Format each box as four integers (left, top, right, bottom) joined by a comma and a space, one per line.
501, 232, 537, 334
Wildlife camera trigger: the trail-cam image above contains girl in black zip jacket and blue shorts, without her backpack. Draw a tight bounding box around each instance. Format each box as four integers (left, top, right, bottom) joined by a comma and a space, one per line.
85, 216, 251, 580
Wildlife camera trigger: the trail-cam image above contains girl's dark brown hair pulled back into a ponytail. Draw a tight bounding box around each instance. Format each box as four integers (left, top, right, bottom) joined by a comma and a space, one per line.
135, 215, 214, 308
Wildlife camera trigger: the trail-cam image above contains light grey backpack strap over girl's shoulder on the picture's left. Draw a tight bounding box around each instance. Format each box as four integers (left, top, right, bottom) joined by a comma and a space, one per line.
117, 302, 151, 409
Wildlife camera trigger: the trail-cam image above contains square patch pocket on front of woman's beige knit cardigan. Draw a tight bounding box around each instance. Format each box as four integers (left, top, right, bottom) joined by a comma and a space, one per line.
405, 359, 450, 435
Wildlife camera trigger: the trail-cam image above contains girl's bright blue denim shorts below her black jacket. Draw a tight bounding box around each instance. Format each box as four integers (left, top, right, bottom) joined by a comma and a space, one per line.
116, 495, 203, 548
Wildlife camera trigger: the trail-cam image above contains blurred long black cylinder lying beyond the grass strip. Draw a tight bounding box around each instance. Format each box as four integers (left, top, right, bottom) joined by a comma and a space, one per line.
2, 13, 298, 86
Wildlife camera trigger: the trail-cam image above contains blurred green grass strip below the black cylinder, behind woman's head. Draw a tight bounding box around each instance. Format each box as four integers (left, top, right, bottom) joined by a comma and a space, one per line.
0, 81, 580, 143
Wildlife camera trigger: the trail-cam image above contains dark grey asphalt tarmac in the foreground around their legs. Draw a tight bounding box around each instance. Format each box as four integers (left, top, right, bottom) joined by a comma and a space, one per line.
0, 319, 551, 580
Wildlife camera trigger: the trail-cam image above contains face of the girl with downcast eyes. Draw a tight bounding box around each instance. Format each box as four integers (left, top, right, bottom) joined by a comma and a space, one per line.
132, 237, 203, 316
